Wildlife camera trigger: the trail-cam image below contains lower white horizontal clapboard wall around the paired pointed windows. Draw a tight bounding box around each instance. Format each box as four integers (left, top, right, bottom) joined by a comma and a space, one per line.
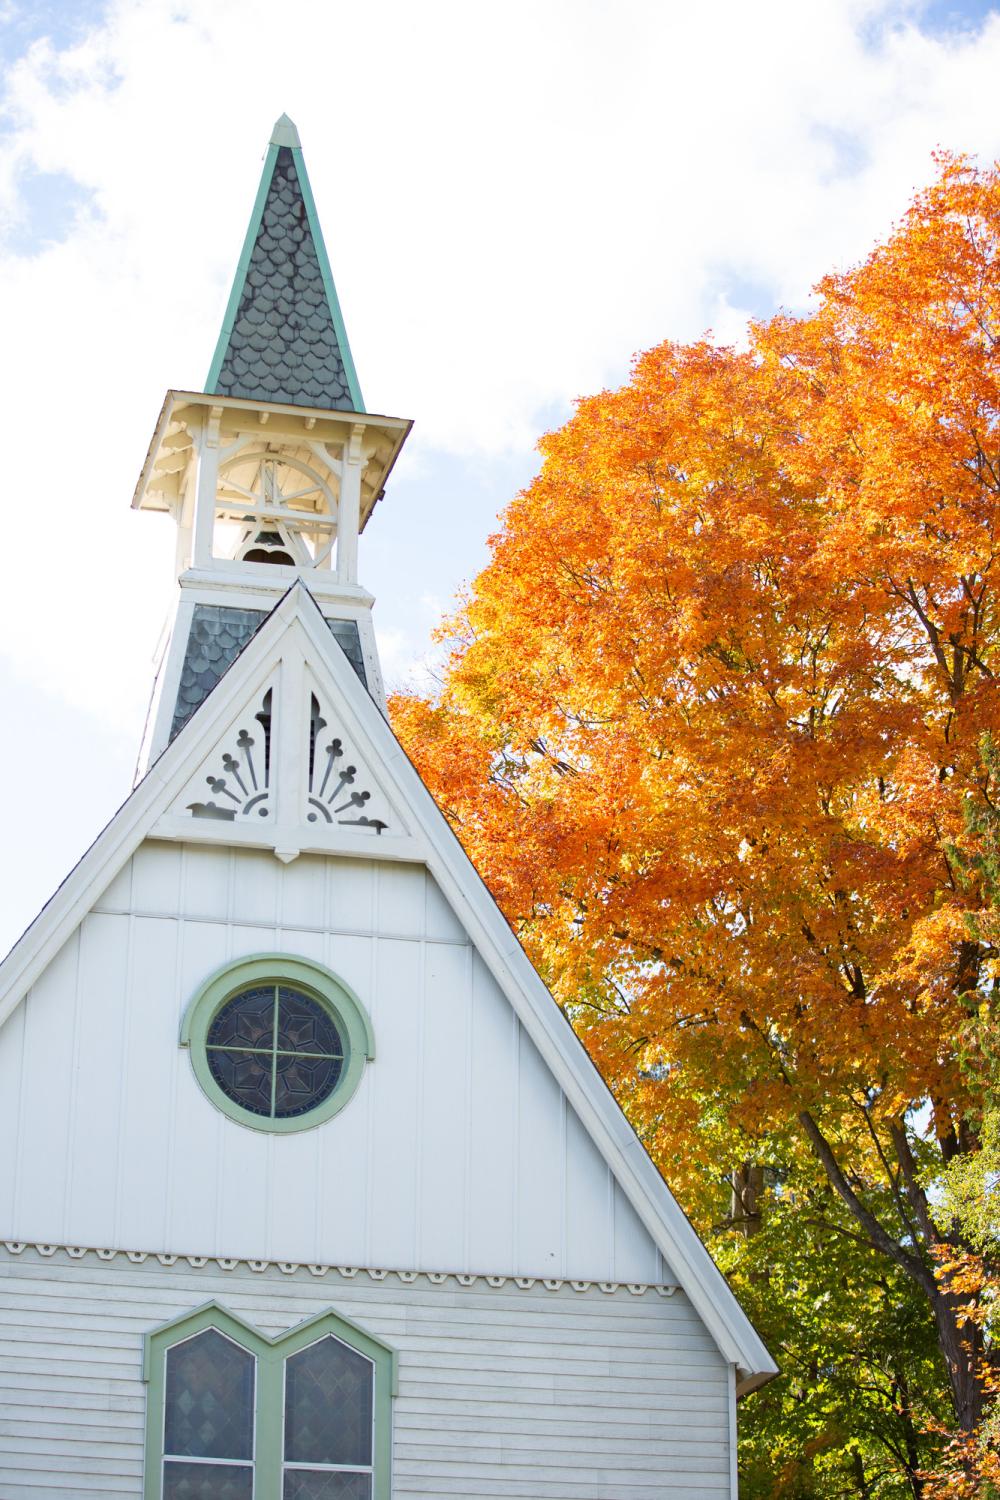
0, 1248, 732, 1500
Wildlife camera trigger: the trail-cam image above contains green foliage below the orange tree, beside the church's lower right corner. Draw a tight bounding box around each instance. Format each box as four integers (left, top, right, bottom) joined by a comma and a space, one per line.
728, 1172, 949, 1500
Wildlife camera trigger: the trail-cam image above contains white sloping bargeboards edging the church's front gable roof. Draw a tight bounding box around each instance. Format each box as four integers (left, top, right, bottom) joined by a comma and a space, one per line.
0, 584, 777, 1394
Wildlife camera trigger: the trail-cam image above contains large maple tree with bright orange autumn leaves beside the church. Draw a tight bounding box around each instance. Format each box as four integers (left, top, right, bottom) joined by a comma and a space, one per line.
391, 158, 1000, 1431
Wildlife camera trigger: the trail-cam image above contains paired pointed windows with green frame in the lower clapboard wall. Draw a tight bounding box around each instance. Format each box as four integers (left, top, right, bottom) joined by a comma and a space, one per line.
144, 1302, 396, 1500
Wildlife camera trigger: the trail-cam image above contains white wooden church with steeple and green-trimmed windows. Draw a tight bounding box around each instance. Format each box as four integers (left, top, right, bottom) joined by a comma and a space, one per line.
0, 117, 775, 1500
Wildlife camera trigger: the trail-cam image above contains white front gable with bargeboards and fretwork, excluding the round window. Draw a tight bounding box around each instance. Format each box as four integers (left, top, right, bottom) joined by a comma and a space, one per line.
0, 587, 774, 1385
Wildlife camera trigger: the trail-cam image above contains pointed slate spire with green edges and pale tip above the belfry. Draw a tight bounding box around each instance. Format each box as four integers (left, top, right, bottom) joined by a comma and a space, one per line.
205, 114, 364, 411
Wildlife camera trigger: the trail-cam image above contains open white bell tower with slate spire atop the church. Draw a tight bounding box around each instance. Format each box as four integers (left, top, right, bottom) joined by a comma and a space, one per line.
132, 116, 411, 770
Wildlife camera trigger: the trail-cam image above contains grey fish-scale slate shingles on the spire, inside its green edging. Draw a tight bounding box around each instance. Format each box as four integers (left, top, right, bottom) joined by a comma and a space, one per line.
213, 146, 361, 411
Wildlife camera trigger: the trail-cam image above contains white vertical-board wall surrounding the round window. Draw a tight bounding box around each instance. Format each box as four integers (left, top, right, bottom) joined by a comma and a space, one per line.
0, 842, 673, 1284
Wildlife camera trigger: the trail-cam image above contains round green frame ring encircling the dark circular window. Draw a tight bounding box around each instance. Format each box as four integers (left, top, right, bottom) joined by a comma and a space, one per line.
180, 953, 375, 1134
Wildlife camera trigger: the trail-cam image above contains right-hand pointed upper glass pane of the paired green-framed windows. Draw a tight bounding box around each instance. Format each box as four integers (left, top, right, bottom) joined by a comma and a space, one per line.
285, 1338, 375, 1464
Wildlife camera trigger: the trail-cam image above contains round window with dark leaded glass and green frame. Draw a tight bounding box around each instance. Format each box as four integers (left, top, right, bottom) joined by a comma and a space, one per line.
180, 953, 375, 1133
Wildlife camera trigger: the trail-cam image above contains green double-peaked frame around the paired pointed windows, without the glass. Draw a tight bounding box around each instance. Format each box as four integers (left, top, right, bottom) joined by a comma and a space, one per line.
142, 1302, 397, 1500
